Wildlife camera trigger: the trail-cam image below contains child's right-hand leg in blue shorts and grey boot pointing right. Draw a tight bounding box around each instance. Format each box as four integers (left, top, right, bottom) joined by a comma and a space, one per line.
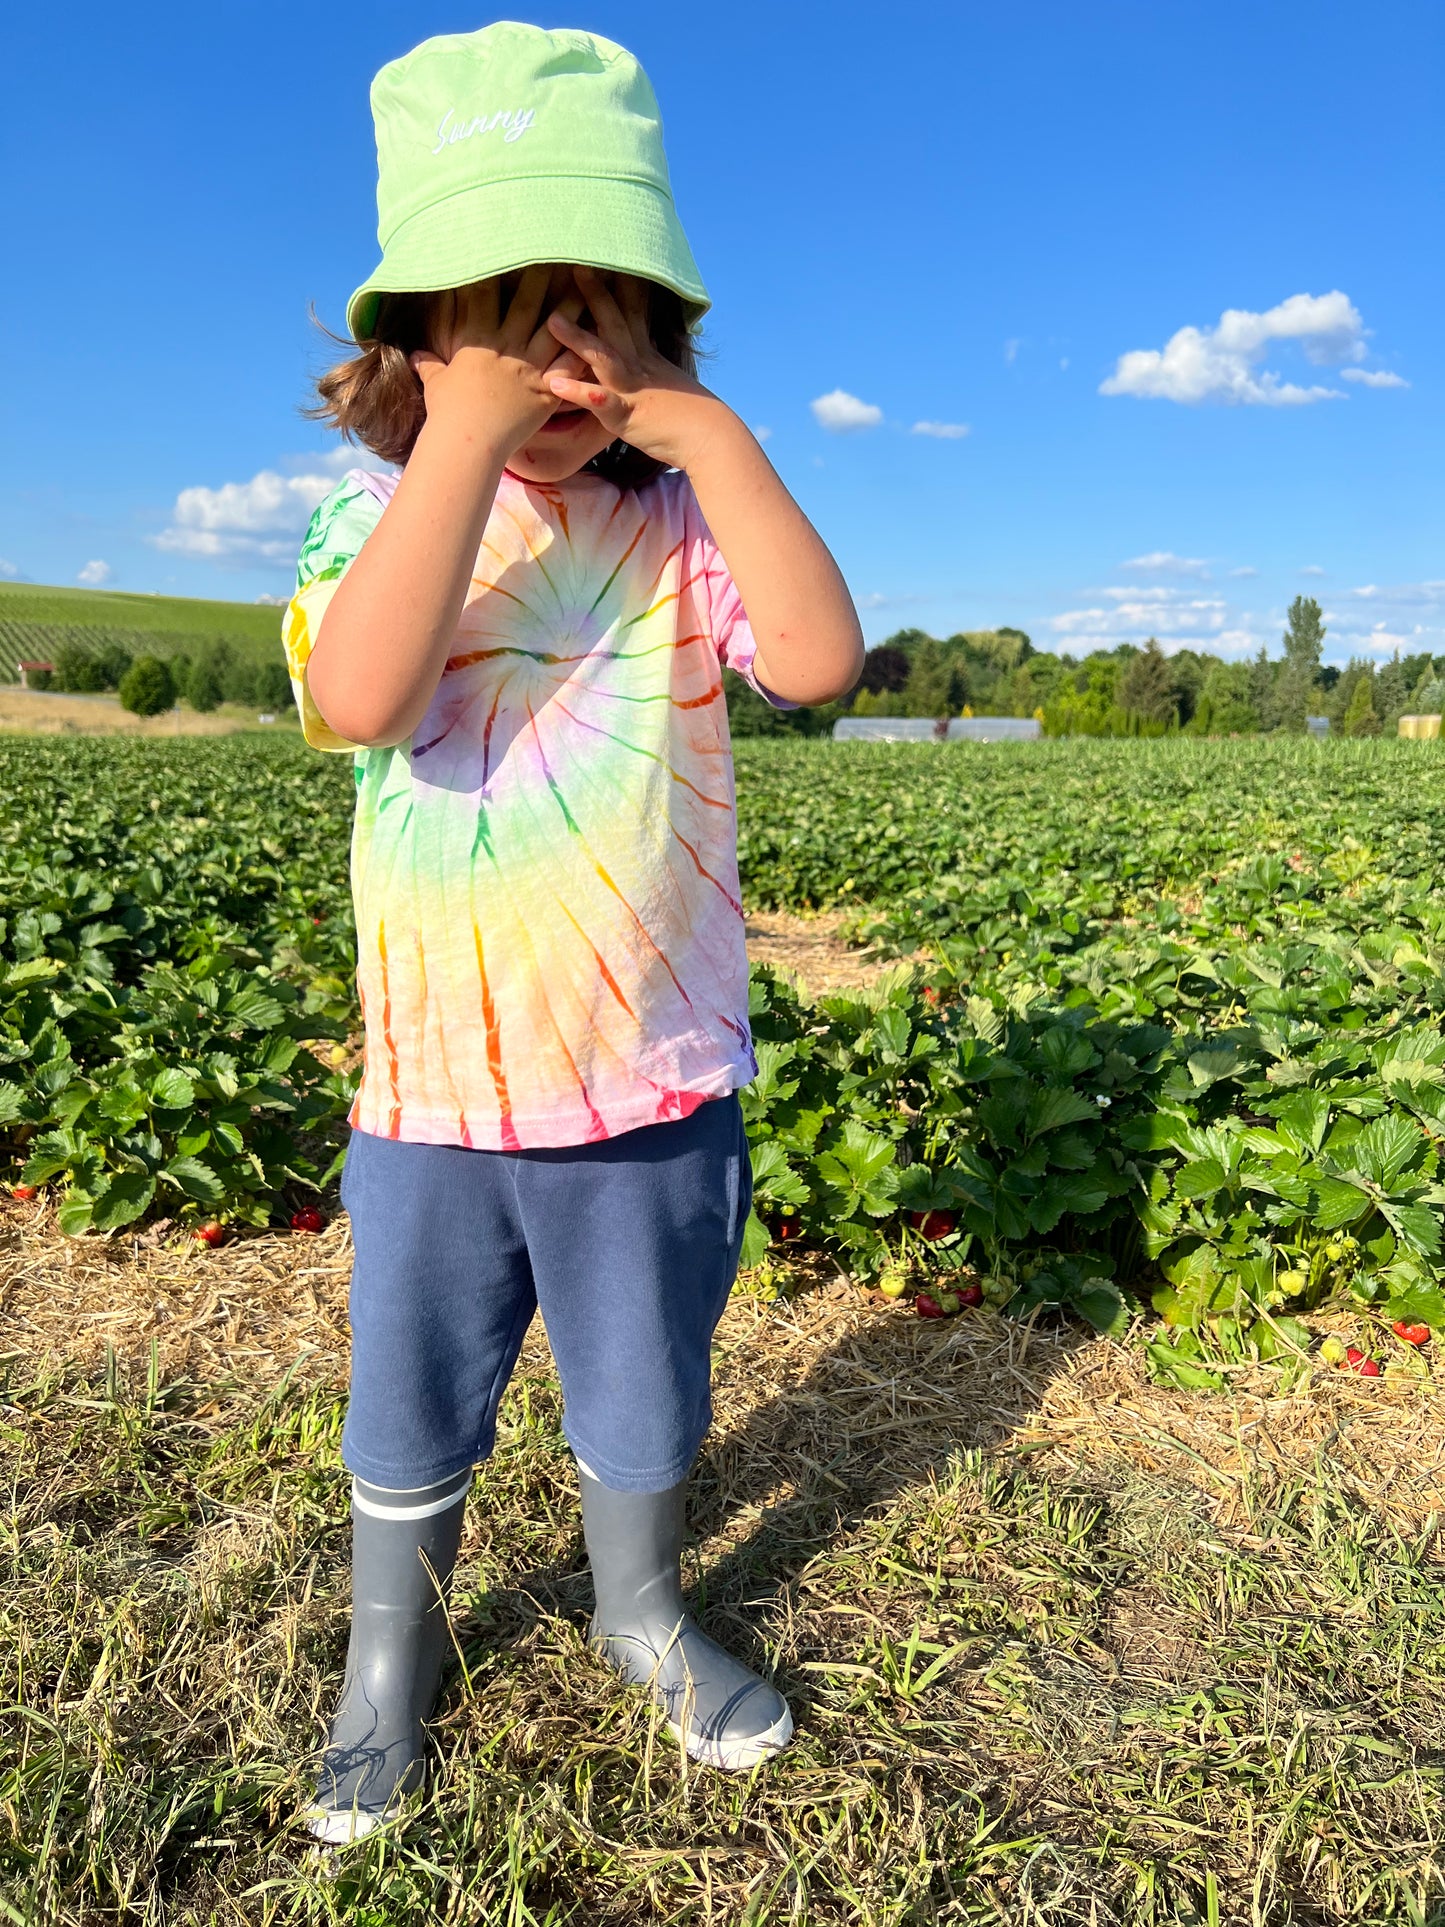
518, 1096, 792, 1767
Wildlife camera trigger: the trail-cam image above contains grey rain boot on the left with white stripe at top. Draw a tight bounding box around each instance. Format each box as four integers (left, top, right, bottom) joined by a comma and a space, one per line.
304, 1466, 472, 1844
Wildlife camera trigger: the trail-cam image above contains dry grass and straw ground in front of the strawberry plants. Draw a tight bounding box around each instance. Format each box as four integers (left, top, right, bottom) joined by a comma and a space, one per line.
0, 1204, 1445, 1927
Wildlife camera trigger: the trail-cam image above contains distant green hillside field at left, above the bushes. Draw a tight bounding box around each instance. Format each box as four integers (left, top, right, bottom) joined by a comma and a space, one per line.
0, 582, 281, 682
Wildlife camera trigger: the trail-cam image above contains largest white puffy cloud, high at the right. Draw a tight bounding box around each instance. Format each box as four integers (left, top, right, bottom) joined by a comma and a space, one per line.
1098, 289, 1366, 409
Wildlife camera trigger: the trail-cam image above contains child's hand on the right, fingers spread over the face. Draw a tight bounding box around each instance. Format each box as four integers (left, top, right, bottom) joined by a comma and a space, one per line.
545, 268, 730, 470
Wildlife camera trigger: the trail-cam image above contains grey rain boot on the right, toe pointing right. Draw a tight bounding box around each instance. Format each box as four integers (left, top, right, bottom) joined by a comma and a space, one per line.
578, 1465, 792, 1771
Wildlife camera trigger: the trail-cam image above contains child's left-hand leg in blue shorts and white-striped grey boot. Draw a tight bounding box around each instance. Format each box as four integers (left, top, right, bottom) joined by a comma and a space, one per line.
306, 1131, 536, 1840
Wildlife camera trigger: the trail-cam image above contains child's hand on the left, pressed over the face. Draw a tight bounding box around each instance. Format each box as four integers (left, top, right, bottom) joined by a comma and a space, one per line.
408, 266, 586, 459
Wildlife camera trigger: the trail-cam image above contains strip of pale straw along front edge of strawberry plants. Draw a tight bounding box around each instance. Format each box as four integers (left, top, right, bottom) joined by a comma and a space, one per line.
0, 1202, 1445, 1542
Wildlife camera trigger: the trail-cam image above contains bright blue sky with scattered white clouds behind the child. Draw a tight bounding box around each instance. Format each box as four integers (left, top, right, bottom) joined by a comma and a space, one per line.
0, 0, 1445, 659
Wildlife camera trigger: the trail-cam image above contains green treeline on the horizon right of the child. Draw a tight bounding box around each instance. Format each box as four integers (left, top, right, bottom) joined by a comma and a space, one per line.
728, 595, 1445, 736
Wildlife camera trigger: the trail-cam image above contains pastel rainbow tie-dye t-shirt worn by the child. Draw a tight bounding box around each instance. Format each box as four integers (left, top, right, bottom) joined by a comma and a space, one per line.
285, 468, 786, 1150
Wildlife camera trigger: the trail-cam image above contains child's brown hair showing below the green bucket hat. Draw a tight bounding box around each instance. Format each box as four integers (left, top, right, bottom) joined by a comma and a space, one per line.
301, 281, 697, 489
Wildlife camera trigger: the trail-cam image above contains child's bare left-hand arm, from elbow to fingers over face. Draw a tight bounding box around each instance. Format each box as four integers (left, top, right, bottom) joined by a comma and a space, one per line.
306, 268, 580, 746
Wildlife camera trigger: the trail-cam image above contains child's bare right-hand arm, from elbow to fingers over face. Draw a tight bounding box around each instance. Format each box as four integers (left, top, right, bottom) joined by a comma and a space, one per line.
547, 268, 863, 703
